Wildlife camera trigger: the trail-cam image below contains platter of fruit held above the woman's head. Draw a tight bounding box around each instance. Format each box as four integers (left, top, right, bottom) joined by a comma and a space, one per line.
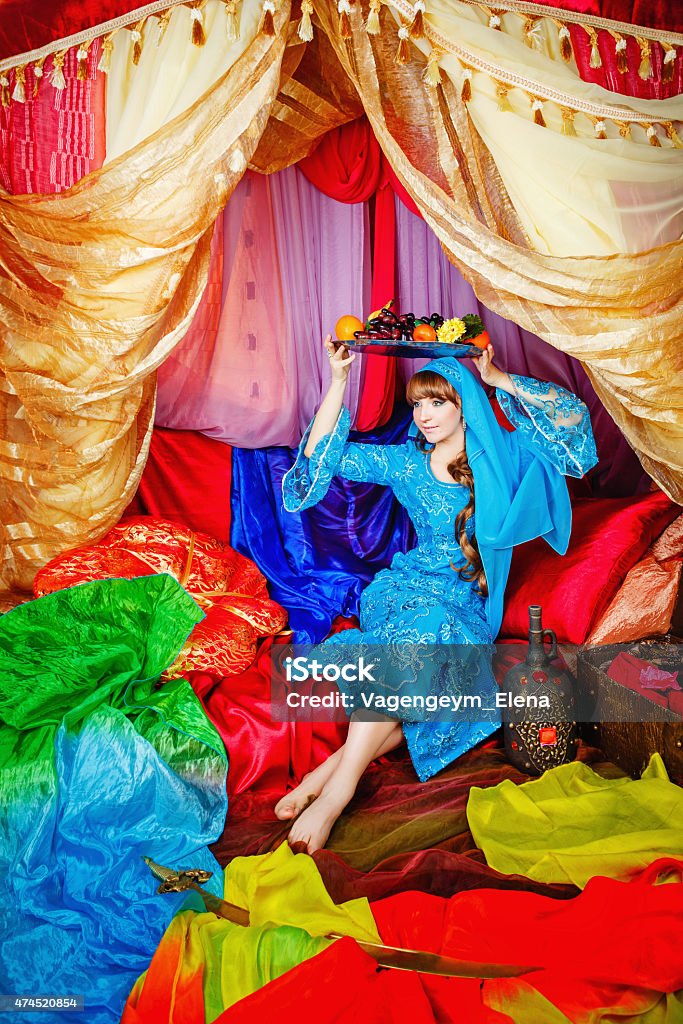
336, 302, 490, 359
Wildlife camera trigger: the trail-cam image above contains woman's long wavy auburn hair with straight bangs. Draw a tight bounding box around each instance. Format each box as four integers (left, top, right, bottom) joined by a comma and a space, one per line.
405, 370, 488, 597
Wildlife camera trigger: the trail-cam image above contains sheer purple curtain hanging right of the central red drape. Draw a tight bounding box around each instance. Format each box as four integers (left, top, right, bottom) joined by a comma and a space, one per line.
395, 199, 650, 498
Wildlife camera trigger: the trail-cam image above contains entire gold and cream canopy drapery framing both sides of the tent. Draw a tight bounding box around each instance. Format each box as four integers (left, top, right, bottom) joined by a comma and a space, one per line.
0, 0, 683, 588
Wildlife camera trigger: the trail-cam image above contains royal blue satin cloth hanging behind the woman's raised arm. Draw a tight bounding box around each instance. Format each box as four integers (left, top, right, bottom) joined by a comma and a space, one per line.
230, 407, 415, 643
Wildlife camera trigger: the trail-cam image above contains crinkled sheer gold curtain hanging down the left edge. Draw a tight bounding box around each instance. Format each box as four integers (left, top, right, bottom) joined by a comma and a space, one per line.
0, 0, 289, 589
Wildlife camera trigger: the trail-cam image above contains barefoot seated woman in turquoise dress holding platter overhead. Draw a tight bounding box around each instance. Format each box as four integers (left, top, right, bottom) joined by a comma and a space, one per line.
275, 336, 597, 853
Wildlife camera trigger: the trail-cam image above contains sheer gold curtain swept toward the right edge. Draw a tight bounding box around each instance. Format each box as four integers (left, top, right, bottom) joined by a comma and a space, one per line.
316, 4, 683, 502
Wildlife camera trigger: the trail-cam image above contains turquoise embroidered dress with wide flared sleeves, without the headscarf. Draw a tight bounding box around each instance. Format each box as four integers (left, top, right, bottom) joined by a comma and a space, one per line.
283, 372, 596, 780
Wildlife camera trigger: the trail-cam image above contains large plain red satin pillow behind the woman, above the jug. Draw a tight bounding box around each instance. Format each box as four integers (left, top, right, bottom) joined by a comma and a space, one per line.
500, 490, 681, 644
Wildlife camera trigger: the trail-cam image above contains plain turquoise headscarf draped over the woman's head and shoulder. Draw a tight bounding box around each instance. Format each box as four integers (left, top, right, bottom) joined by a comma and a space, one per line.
410, 358, 571, 637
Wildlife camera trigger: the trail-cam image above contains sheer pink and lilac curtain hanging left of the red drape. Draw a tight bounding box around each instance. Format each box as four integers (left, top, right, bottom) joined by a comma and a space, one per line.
157, 167, 370, 447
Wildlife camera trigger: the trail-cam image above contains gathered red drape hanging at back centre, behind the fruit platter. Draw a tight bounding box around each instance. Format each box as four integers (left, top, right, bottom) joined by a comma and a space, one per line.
298, 118, 396, 430
